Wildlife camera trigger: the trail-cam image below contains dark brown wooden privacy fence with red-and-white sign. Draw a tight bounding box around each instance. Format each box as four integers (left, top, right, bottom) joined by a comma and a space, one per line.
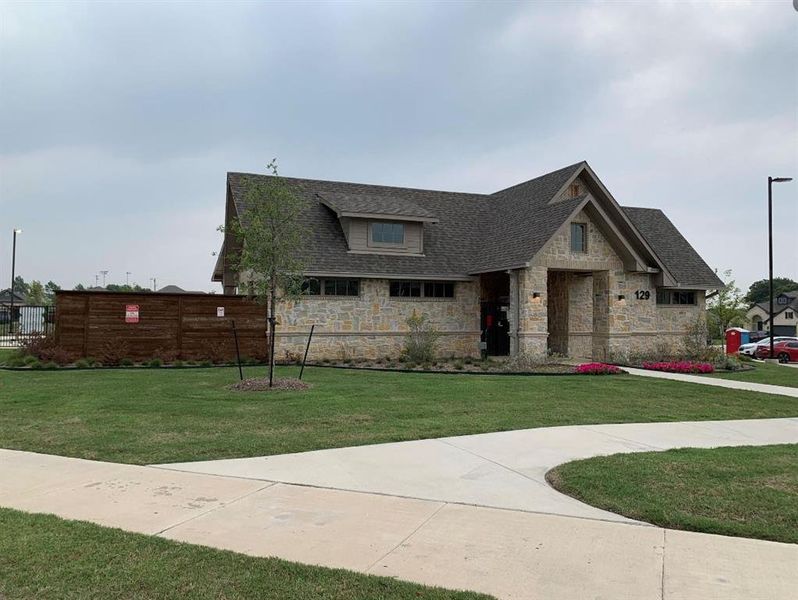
55, 291, 268, 361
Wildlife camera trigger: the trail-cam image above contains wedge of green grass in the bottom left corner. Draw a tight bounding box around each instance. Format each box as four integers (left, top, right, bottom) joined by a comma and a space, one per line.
0, 509, 488, 600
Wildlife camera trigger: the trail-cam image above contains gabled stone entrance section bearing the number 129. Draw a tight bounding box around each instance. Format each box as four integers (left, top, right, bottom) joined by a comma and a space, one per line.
511, 212, 705, 360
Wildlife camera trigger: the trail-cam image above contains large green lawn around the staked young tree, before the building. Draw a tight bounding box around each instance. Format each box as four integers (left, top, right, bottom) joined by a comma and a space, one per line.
0, 367, 798, 464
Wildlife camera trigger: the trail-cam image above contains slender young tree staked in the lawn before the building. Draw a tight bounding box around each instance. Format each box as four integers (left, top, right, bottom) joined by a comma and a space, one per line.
228, 159, 308, 386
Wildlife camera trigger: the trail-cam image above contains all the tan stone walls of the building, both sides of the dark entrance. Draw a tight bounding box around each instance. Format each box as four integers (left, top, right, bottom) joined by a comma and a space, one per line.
277, 212, 705, 360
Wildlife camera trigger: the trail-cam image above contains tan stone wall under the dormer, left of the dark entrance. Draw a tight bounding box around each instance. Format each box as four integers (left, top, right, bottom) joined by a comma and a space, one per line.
275, 279, 480, 360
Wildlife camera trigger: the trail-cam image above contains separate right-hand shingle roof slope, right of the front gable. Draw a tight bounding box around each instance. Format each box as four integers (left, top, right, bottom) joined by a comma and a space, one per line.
623, 206, 723, 289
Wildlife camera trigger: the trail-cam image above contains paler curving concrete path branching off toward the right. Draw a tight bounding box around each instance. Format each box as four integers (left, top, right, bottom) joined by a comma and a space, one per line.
158, 418, 798, 521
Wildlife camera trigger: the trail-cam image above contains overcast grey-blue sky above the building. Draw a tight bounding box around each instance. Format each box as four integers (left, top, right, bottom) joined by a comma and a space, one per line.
0, 0, 798, 290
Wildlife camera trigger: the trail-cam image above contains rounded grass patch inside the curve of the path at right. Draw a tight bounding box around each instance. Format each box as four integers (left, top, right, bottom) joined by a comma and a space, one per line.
547, 445, 798, 544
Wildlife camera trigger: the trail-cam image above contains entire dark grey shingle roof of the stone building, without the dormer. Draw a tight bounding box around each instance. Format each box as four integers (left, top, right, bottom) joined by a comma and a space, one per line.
227, 162, 719, 289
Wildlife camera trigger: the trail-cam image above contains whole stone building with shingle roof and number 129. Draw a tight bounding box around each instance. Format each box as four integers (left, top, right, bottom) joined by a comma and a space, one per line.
212, 157, 722, 360
